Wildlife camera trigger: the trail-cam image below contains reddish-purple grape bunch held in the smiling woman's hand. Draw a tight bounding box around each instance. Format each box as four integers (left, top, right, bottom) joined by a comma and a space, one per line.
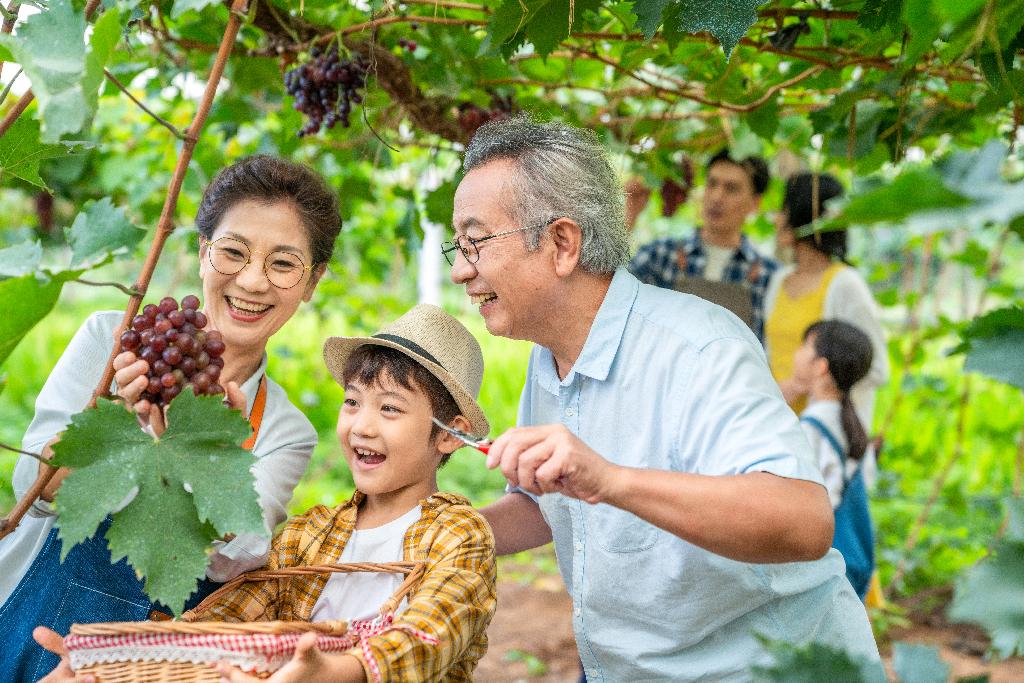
121, 294, 224, 405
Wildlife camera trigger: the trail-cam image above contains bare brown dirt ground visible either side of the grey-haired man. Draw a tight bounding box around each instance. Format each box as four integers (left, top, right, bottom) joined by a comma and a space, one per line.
476, 557, 1024, 683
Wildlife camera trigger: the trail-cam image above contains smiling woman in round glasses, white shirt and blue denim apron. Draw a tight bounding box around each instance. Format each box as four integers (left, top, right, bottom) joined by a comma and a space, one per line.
0, 156, 341, 681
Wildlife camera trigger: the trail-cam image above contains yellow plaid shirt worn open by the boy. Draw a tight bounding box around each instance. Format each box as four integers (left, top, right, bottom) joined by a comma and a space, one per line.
182, 492, 497, 682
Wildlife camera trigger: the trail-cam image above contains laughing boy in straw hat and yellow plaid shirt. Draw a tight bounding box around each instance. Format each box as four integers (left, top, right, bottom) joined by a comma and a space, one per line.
191, 304, 496, 681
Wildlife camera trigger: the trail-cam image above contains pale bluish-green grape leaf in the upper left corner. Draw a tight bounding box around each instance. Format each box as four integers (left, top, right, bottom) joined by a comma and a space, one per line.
0, 0, 88, 142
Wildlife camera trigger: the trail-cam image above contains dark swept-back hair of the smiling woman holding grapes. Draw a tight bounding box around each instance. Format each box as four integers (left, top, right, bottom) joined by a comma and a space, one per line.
196, 155, 341, 265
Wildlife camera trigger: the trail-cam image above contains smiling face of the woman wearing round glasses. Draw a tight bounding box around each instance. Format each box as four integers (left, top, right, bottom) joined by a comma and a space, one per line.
194, 201, 323, 354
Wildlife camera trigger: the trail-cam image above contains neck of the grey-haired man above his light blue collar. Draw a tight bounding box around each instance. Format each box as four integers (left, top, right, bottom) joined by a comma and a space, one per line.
530, 272, 611, 379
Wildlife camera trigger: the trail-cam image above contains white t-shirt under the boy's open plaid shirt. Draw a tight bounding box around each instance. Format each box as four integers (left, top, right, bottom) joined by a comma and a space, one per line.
311, 506, 421, 622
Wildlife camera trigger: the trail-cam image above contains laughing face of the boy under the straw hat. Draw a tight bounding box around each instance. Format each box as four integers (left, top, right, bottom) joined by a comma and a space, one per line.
337, 373, 459, 514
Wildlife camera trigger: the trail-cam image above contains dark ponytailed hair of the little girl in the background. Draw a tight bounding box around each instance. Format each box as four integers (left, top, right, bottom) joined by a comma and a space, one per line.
804, 321, 874, 460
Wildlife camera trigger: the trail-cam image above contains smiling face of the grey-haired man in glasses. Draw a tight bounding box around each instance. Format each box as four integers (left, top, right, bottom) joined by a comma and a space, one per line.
452, 160, 558, 340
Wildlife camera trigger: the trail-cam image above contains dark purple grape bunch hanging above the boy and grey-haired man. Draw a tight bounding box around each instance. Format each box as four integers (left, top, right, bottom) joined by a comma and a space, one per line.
285, 45, 367, 137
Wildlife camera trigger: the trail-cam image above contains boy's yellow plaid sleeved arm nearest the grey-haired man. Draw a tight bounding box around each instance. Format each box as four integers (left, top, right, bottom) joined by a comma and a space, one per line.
348, 505, 497, 681
